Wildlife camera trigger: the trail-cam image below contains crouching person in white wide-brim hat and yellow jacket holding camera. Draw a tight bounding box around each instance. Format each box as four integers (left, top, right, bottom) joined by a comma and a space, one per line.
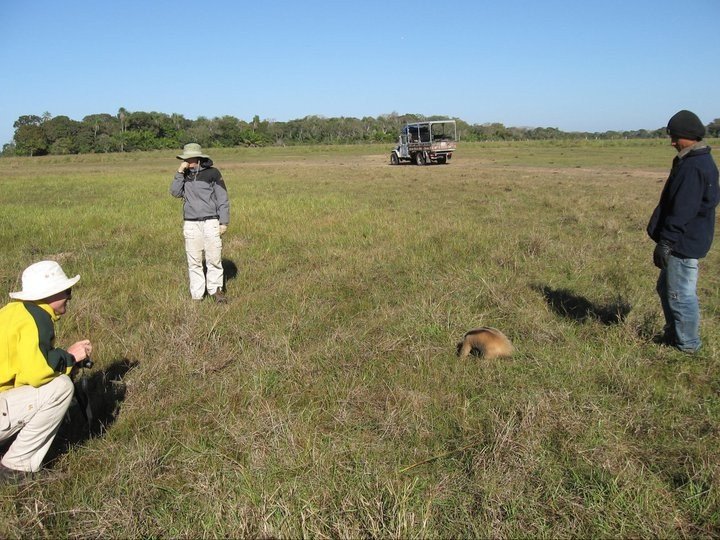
0, 261, 92, 484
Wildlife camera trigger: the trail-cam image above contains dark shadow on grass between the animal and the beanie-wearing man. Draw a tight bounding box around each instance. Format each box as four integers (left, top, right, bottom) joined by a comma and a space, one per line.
532, 285, 632, 326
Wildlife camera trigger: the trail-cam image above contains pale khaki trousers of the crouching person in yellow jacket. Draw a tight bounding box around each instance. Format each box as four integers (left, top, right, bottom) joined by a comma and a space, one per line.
0, 375, 75, 472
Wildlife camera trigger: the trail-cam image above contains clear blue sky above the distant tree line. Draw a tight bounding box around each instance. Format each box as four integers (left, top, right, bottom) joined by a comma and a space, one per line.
0, 0, 720, 145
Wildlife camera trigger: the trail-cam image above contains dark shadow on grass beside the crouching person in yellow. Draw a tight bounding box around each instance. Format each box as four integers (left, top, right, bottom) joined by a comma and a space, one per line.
45, 358, 138, 462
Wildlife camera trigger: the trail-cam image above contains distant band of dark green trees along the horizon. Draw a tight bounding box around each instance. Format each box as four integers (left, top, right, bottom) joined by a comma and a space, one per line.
2, 108, 720, 156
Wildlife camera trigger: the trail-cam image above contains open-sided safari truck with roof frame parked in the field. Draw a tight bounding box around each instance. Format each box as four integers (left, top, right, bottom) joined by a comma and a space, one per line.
390, 120, 457, 165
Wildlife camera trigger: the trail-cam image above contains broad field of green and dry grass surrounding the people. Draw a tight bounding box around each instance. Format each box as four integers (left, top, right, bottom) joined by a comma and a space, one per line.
0, 141, 720, 538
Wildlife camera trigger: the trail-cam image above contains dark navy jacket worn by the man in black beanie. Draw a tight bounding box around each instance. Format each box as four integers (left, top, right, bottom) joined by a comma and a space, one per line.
647, 146, 720, 259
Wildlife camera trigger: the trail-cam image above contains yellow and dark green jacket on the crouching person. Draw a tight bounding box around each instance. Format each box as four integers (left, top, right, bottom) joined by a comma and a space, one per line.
0, 301, 75, 392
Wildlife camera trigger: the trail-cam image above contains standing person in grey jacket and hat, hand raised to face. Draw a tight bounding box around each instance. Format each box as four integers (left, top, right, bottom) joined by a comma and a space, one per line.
170, 143, 230, 302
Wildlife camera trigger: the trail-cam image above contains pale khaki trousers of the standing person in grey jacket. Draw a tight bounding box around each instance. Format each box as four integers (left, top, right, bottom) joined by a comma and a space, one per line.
183, 219, 223, 300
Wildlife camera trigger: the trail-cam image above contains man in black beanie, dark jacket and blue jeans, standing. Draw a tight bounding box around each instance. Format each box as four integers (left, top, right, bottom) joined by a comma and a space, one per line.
647, 110, 720, 353
